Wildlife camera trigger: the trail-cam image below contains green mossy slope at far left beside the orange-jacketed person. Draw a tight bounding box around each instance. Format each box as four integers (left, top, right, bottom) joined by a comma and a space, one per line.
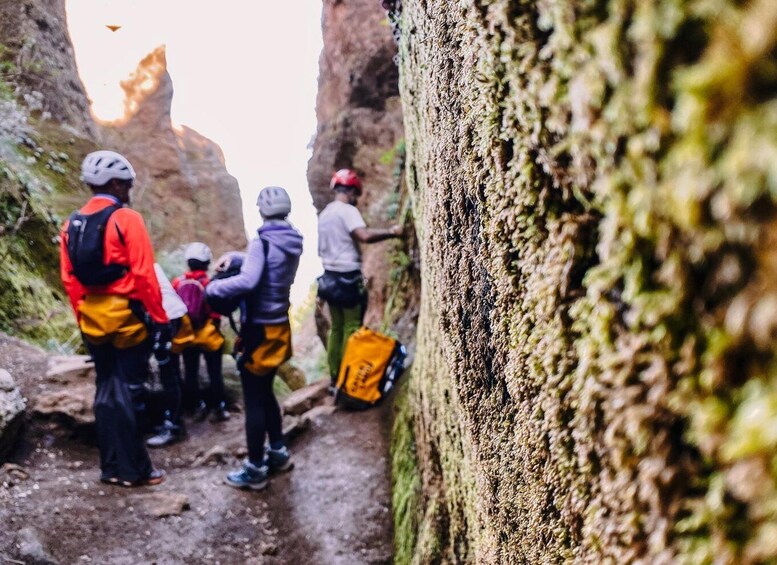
0, 115, 92, 351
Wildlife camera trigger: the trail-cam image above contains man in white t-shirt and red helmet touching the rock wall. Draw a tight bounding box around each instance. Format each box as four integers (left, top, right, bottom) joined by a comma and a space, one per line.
318, 169, 402, 386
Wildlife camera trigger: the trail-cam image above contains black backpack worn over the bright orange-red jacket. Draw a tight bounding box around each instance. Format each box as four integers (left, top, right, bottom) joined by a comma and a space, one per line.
67, 204, 129, 286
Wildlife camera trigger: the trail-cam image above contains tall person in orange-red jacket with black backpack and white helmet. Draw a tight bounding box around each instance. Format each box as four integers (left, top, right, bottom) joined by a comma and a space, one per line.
60, 151, 171, 486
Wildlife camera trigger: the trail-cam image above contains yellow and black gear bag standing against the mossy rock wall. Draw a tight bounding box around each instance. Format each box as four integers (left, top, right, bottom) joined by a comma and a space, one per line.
335, 327, 407, 409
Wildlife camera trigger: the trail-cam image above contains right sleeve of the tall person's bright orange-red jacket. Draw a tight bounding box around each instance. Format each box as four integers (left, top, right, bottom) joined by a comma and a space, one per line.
116, 208, 169, 324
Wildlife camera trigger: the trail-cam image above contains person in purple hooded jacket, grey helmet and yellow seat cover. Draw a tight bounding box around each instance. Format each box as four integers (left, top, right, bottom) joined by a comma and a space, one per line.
205, 186, 302, 490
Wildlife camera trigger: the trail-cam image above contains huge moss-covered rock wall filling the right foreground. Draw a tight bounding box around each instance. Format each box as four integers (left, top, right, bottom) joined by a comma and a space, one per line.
394, 0, 777, 563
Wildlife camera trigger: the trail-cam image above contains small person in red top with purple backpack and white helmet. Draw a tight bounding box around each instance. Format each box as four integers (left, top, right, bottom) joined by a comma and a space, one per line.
173, 241, 230, 422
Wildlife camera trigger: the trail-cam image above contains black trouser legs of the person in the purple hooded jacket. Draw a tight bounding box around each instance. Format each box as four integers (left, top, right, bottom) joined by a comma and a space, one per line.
240, 369, 283, 466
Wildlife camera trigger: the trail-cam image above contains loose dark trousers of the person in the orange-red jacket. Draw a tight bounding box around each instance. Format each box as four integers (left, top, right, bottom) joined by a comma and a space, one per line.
87, 343, 153, 482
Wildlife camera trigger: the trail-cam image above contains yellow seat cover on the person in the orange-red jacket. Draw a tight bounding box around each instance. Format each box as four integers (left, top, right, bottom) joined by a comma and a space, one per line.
78, 294, 148, 349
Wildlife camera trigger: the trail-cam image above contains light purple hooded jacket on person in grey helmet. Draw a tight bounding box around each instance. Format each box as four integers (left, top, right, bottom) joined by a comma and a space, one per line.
205, 220, 302, 324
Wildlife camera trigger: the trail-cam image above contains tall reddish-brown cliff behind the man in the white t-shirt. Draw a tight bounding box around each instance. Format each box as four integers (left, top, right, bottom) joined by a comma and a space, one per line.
308, 0, 410, 326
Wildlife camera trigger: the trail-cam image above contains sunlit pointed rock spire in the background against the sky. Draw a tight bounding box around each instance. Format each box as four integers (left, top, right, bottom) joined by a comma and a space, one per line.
103, 47, 246, 255
